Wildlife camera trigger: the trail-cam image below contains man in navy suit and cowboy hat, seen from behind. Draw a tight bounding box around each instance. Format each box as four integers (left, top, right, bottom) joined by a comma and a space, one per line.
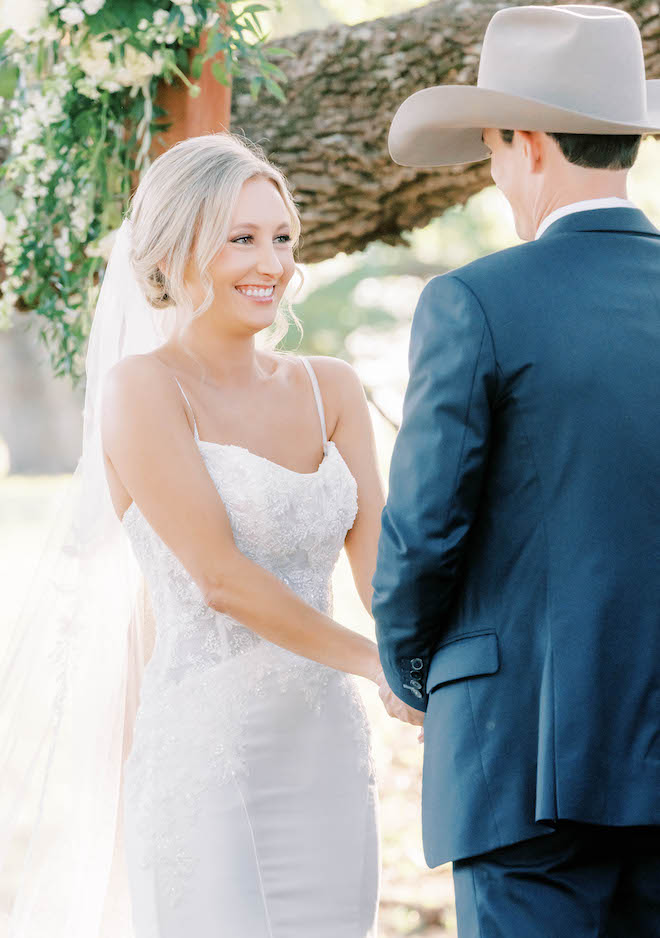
373, 6, 660, 938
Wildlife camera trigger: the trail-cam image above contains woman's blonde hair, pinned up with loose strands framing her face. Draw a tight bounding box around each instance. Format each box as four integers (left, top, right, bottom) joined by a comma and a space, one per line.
130, 133, 301, 358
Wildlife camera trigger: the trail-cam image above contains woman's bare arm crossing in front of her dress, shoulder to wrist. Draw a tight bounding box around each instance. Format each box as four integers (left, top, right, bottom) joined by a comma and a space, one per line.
101, 355, 380, 682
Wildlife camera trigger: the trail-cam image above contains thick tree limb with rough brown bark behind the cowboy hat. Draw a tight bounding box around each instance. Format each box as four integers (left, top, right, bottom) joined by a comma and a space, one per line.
232, 0, 660, 262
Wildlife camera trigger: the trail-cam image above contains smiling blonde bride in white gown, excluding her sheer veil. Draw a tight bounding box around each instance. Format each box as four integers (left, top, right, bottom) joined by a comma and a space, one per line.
94, 134, 423, 938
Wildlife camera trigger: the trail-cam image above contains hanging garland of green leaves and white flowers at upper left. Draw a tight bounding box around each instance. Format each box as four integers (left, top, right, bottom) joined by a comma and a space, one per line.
0, 0, 289, 386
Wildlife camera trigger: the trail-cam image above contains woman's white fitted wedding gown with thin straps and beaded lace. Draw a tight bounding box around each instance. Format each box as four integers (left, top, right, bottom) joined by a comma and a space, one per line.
117, 359, 380, 938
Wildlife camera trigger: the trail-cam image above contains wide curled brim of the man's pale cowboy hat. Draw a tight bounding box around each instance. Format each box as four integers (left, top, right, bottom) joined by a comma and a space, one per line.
388, 80, 660, 166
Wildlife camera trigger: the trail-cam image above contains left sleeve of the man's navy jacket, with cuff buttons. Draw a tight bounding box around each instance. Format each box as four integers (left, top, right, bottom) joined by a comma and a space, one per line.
372, 274, 497, 710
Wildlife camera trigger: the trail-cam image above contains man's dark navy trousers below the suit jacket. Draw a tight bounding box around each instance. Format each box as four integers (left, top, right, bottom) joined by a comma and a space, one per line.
454, 822, 660, 938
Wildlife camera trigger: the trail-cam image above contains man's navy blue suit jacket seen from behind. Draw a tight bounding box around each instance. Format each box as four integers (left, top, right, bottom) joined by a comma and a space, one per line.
373, 208, 660, 867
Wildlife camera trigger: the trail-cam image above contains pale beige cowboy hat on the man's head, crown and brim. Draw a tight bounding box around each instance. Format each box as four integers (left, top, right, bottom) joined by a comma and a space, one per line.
388, 5, 660, 166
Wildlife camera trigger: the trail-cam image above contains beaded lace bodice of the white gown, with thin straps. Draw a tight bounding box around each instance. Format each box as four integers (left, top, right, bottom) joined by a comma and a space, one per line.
122, 359, 357, 720
